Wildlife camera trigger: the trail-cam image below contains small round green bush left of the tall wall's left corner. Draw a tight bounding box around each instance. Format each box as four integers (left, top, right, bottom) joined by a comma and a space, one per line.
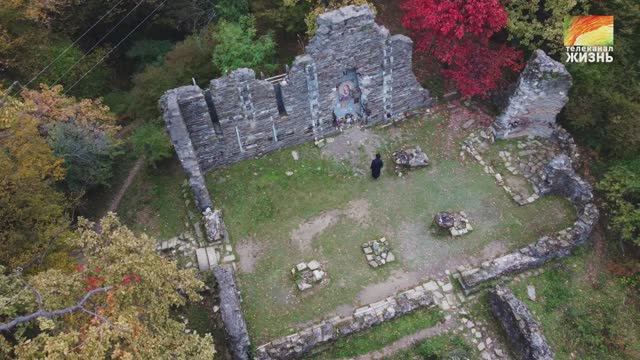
130, 123, 173, 168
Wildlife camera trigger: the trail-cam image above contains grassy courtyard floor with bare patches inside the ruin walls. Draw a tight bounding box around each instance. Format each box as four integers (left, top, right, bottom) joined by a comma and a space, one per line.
207, 114, 574, 344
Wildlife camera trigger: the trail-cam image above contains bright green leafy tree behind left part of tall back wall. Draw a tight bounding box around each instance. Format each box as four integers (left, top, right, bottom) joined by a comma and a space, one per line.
213, 17, 276, 73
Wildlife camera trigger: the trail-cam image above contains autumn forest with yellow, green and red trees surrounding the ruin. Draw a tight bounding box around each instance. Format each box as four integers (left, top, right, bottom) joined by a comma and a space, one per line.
0, 0, 640, 359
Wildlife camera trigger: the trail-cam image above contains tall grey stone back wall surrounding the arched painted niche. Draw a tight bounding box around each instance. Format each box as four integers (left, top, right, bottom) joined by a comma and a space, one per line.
161, 6, 431, 172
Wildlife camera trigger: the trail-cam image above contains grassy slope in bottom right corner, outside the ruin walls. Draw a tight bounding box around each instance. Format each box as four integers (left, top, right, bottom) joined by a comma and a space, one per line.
512, 249, 640, 360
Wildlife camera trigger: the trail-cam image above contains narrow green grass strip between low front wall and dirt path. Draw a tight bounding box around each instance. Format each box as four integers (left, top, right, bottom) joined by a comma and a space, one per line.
310, 309, 443, 359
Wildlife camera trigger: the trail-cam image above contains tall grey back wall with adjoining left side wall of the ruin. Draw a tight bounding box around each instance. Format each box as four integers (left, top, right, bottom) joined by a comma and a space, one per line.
159, 6, 432, 359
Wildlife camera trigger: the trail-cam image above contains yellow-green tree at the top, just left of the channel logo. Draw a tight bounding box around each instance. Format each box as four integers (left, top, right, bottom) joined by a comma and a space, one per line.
504, 0, 590, 57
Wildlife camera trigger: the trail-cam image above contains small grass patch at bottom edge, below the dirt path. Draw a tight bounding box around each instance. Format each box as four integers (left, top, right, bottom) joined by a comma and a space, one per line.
388, 333, 476, 360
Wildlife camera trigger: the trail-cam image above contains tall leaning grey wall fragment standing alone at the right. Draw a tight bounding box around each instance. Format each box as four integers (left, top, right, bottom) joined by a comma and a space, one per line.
494, 50, 572, 139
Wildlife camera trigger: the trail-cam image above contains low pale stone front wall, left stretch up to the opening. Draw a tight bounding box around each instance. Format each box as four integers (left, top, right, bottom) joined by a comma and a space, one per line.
256, 281, 440, 360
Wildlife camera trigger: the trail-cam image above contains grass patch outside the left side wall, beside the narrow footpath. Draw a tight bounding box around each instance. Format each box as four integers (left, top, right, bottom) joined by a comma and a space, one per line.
118, 159, 191, 239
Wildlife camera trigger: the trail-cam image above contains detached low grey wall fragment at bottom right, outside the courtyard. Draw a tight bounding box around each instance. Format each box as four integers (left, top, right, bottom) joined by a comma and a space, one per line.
489, 286, 554, 360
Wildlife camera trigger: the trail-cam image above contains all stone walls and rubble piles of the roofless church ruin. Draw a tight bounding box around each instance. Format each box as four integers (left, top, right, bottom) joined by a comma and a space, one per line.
160, 6, 599, 360
